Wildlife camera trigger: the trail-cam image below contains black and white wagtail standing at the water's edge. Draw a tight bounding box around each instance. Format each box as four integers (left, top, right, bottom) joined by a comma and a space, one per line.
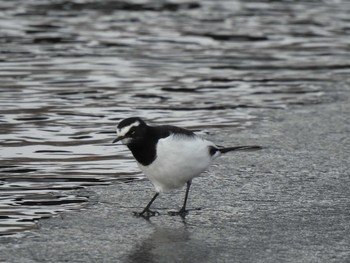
113, 117, 262, 219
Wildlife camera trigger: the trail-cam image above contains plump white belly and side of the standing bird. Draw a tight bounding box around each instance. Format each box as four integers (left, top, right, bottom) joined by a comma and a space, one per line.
138, 135, 215, 192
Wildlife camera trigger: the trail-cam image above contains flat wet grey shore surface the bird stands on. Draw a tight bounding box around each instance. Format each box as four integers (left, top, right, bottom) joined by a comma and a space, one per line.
0, 93, 350, 263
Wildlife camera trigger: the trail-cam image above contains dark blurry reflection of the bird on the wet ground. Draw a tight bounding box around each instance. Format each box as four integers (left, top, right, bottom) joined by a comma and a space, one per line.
126, 224, 208, 263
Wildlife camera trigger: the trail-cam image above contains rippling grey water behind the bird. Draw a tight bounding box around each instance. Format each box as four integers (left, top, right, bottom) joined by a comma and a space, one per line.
0, 0, 350, 235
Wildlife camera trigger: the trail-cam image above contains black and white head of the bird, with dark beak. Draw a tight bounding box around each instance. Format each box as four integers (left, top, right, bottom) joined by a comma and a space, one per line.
113, 117, 147, 145
